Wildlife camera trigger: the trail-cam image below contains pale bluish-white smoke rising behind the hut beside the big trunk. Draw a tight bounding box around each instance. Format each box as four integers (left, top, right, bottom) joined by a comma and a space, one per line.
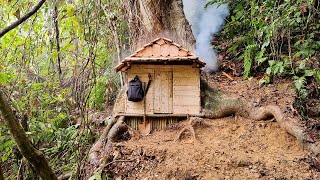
182, 0, 229, 71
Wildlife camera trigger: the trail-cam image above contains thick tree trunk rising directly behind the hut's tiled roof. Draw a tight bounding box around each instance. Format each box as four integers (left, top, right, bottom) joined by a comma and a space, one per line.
123, 0, 195, 50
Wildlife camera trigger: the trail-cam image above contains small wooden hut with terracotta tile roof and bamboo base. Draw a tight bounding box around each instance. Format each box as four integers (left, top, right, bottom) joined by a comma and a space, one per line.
115, 38, 205, 130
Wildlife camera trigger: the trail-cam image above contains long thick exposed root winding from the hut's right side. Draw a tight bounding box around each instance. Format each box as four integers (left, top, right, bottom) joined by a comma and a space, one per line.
201, 81, 320, 155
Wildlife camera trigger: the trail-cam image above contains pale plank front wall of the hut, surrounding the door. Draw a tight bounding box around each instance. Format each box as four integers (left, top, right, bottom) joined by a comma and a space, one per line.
125, 64, 201, 114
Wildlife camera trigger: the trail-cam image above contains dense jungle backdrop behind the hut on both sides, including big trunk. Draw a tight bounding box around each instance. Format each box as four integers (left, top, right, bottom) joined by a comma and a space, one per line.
0, 0, 320, 179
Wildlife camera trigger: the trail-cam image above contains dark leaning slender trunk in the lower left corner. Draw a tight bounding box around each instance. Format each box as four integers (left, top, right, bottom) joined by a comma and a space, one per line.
0, 89, 57, 180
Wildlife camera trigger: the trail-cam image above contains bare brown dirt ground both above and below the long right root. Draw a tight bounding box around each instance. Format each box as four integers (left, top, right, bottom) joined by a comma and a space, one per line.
103, 73, 320, 179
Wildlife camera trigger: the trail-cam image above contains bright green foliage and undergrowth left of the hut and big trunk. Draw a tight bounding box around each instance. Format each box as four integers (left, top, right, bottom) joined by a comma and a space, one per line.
0, 0, 128, 179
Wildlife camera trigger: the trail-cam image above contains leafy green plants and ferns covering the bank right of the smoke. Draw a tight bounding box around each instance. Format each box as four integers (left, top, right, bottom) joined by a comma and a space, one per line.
206, 0, 320, 116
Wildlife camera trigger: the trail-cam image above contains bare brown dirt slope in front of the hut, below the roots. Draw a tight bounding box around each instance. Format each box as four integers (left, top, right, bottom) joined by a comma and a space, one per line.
105, 117, 312, 179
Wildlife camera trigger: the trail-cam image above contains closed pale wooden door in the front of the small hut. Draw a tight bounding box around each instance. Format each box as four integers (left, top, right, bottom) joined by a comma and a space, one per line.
153, 71, 173, 114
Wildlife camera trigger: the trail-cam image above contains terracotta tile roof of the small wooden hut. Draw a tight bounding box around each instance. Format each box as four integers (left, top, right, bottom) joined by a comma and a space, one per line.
115, 37, 206, 71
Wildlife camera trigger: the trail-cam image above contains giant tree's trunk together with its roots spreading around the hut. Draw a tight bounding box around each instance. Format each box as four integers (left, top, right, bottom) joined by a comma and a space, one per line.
89, 0, 320, 172
